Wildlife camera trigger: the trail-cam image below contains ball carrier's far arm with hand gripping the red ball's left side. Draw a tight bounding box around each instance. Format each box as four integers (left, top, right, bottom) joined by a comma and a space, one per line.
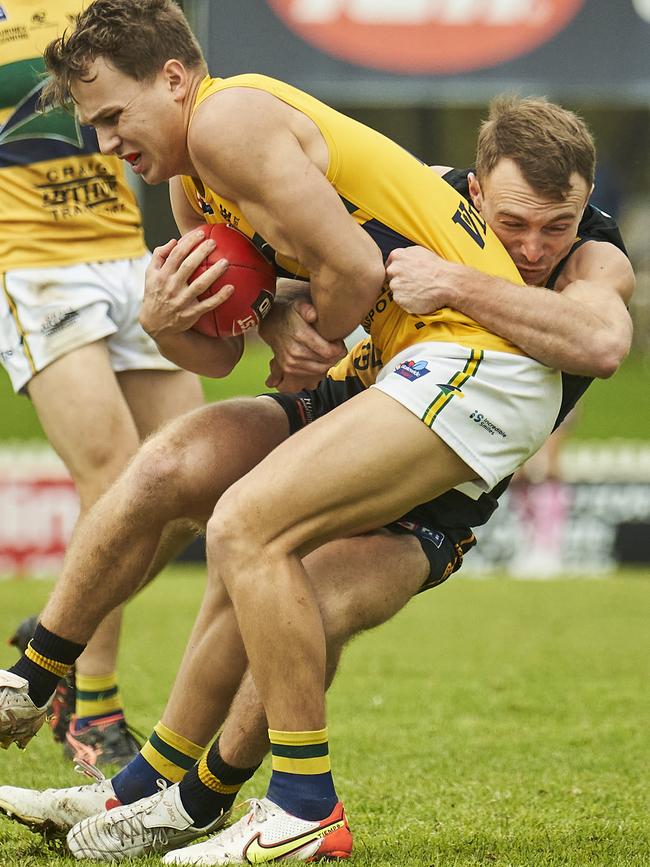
140, 178, 244, 378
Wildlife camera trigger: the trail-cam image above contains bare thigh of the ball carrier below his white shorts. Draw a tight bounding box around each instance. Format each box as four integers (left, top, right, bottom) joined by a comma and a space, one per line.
215, 389, 476, 555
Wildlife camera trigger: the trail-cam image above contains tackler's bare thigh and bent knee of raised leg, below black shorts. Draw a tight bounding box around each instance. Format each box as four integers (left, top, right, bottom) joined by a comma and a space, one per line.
134, 397, 289, 523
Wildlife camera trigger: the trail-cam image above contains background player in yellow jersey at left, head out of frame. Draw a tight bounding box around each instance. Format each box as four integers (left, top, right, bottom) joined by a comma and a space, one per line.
0, 0, 202, 763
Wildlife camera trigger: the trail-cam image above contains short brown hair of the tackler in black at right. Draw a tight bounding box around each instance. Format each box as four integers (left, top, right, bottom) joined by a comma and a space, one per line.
476, 94, 596, 200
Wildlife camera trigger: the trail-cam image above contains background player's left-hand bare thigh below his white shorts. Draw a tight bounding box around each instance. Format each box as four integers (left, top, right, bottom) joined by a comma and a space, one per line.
27, 340, 138, 500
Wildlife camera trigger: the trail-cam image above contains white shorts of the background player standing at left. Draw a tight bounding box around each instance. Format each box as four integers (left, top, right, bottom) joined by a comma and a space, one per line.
0, 254, 178, 392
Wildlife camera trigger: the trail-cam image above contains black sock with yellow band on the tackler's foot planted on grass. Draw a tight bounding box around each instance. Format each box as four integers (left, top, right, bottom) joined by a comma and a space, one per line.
180, 738, 259, 828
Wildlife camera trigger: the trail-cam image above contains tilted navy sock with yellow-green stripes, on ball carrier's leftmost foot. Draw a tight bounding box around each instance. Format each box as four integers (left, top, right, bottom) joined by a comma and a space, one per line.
112, 722, 205, 804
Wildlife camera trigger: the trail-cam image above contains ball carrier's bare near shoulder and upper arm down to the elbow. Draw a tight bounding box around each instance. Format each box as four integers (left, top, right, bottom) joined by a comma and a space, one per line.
188, 88, 385, 341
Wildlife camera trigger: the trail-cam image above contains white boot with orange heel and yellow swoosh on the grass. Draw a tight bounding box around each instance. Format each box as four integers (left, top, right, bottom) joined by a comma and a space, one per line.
163, 798, 352, 864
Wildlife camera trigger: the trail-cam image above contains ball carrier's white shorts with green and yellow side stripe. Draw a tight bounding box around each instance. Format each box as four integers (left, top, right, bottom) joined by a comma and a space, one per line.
371, 342, 562, 499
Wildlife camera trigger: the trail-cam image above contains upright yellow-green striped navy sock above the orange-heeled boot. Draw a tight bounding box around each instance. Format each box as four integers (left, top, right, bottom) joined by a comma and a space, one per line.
266, 728, 338, 822
